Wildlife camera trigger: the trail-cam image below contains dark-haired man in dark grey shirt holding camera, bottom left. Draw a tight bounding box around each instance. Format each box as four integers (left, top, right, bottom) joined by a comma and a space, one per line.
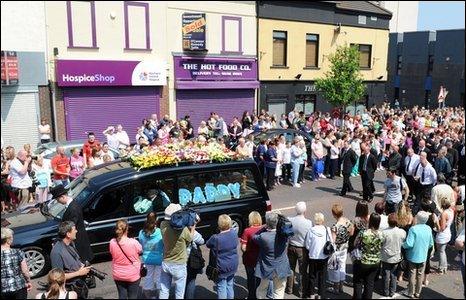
50, 221, 91, 298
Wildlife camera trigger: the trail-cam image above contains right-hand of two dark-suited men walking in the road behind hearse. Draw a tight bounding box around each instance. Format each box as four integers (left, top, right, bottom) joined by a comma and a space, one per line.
358, 144, 377, 202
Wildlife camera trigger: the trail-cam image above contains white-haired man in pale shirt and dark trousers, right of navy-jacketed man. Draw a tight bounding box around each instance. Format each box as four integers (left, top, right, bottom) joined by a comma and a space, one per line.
285, 202, 312, 296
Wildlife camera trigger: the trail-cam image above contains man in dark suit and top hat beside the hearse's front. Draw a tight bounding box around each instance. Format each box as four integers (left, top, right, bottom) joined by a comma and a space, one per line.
52, 185, 94, 262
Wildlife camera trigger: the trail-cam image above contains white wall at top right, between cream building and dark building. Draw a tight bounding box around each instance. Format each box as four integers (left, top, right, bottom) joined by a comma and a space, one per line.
380, 1, 419, 32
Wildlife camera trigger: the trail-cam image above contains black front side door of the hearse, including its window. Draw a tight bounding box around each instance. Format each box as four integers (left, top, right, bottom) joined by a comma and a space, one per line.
83, 184, 132, 254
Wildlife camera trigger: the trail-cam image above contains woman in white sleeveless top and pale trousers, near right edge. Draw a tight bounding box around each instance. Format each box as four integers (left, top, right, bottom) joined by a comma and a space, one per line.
435, 199, 454, 274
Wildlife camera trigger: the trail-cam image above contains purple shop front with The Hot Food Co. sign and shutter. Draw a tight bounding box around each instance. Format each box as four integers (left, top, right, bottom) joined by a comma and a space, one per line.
174, 56, 259, 131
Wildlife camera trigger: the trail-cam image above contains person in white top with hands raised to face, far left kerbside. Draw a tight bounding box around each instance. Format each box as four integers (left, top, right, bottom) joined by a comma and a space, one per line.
10, 150, 32, 209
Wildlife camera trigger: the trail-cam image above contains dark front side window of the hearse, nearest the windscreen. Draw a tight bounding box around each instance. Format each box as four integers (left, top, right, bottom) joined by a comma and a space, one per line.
84, 186, 130, 222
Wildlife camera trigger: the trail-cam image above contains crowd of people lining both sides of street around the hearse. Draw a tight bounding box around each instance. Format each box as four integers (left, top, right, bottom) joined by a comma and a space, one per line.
2, 104, 465, 299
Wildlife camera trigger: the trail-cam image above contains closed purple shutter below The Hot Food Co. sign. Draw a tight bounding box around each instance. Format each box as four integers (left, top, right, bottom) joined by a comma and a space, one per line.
176, 89, 254, 134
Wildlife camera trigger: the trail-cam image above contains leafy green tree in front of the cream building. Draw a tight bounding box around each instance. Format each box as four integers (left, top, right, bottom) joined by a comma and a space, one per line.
316, 45, 366, 119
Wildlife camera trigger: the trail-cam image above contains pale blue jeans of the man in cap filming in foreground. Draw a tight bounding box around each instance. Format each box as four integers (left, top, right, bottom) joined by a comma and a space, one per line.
159, 262, 187, 299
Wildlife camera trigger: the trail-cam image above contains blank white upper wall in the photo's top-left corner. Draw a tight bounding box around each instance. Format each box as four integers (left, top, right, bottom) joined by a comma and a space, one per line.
1, 1, 46, 52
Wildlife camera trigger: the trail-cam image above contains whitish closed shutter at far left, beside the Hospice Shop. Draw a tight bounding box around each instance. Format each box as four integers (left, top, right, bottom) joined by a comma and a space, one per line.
1, 92, 39, 152
